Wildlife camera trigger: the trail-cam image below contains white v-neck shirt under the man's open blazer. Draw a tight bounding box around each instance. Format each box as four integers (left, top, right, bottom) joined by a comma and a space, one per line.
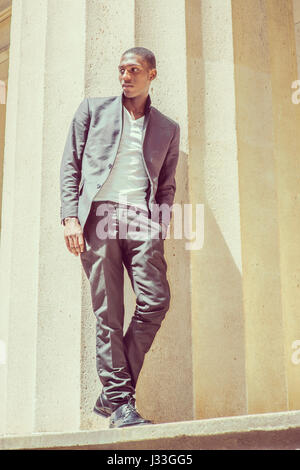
94, 105, 149, 211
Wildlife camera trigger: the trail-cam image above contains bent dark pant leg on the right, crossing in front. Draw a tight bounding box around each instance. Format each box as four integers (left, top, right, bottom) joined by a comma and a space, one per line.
119, 209, 170, 387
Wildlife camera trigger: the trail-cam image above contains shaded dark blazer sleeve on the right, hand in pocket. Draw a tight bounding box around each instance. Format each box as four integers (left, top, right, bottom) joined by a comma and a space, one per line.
155, 124, 180, 225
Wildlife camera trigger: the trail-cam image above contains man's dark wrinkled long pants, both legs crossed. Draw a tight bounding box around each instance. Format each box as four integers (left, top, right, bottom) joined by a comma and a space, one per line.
80, 201, 170, 409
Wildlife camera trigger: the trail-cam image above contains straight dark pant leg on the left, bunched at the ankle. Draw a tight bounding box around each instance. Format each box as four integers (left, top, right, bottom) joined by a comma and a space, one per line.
80, 202, 135, 409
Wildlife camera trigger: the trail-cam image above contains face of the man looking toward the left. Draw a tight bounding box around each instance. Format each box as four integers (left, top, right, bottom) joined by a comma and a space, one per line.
119, 53, 156, 98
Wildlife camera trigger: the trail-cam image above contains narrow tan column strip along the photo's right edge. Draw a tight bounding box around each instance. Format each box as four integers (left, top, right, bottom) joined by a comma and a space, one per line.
266, 0, 300, 410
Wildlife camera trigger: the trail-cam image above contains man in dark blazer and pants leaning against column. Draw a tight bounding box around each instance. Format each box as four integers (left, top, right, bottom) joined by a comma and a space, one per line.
60, 47, 180, 427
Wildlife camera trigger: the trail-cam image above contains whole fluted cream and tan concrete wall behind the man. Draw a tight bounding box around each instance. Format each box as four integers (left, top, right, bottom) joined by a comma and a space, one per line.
0, 0, 300, 442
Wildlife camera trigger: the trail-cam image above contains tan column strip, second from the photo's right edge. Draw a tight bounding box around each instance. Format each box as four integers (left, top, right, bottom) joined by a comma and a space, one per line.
232, 0, 287, 413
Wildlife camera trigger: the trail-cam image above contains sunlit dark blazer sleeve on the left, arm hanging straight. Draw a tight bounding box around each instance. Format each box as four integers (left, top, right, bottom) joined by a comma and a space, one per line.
60, 98, 90, 224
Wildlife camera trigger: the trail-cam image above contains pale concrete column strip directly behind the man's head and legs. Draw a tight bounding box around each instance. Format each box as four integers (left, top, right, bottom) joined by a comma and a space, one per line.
80, 0, 134, 429
